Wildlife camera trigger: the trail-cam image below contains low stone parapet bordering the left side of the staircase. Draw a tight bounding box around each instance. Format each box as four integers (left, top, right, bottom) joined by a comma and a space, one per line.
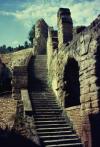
12, 50, 40, 145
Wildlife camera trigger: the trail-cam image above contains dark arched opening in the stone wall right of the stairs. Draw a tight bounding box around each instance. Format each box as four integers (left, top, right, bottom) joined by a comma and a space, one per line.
63, 58, 80, 107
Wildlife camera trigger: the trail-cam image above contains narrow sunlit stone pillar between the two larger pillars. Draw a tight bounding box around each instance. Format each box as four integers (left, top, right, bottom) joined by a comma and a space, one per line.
47, 27, 58, 69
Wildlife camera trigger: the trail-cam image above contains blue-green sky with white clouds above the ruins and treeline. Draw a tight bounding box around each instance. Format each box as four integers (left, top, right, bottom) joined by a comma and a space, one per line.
0, 0, 100, 47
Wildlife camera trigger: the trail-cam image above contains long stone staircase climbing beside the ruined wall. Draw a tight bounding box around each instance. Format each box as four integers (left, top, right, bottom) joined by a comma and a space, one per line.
29, 55, 82, 147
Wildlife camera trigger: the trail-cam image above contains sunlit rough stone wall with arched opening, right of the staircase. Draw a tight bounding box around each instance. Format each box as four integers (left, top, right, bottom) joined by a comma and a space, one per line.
47, 8, 100, 147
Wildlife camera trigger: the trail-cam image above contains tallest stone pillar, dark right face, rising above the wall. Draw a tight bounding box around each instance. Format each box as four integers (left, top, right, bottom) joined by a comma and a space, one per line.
57, 8, 73, 48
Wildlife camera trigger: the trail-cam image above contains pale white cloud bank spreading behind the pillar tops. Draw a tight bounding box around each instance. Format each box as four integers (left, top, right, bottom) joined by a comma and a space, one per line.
0, 0, 100, 29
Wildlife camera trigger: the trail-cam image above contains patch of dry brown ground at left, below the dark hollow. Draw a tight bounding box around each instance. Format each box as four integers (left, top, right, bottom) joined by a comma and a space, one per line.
0, 95, 17, 129
